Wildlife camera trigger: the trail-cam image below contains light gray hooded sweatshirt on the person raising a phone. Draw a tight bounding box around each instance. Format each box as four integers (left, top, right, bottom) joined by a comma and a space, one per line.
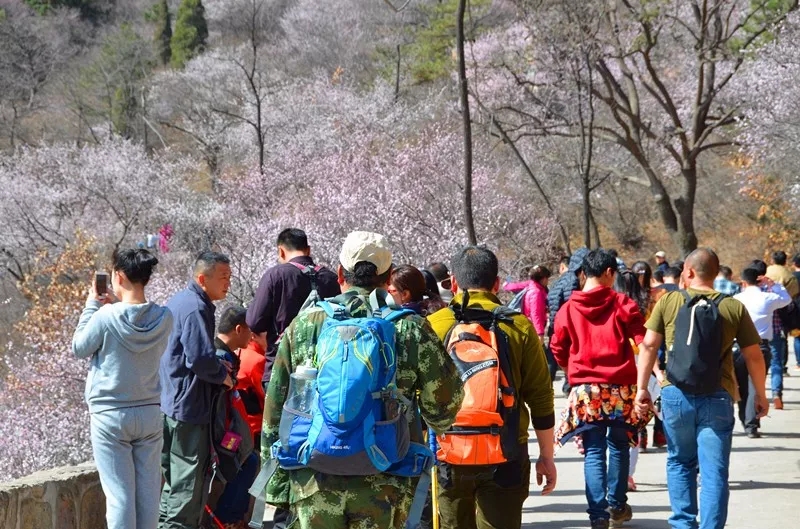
72, 300, 172, 413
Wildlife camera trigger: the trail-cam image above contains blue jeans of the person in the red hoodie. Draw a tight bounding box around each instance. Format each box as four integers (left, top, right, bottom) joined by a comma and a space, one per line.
582, 426, 631, 521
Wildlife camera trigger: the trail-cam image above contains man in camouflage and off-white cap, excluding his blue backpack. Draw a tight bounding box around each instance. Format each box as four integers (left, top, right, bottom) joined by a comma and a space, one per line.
261, 232, 464, 529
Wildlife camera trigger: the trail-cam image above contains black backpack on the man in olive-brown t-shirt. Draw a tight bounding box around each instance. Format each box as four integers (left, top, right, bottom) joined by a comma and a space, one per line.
667, 290, 727, 395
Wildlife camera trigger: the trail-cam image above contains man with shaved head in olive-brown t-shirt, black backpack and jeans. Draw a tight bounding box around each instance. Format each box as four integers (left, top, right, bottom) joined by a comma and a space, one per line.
636, 248, 769, 529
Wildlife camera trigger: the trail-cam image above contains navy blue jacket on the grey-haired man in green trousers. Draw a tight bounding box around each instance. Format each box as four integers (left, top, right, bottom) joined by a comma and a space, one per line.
159, 280, 227, 424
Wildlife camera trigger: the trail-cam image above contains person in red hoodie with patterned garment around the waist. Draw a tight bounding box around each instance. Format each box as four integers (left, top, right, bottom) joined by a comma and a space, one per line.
550, 250, 646, 529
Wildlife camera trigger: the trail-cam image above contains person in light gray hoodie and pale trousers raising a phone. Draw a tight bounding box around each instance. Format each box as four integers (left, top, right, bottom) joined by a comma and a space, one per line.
72, 250, 173, 529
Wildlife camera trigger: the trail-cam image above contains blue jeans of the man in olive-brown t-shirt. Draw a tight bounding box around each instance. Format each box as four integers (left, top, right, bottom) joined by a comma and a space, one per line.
661, 386, 734, 529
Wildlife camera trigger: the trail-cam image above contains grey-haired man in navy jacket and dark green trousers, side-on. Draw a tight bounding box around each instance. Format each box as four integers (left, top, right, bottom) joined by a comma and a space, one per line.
159, 252, 233, 529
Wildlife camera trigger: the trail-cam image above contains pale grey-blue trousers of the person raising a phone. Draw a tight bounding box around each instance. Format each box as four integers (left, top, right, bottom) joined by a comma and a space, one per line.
91, 404, 164, 529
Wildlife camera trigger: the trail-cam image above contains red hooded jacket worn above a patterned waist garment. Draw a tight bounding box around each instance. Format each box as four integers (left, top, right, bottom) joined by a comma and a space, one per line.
550, 287, 645, 386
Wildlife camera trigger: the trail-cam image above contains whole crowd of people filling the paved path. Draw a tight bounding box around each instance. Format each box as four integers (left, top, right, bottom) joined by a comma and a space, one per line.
73, 229, 800, 529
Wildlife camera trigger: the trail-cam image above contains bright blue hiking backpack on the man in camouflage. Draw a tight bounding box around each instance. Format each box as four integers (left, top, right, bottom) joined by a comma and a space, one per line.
250, 291, 433, 527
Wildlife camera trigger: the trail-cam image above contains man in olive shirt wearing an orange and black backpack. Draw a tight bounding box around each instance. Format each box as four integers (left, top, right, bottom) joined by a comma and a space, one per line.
428, 246, 556, 529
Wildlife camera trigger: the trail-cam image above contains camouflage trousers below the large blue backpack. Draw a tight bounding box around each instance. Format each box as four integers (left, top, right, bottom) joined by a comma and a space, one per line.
289, 485, 412, 529
